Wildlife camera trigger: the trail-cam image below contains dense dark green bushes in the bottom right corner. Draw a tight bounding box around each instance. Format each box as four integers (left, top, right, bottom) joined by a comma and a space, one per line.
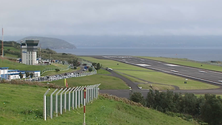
130, 90, 222, 125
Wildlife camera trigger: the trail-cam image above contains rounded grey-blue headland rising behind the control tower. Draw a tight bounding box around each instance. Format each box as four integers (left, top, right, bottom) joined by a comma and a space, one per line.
18, 36, 76, 49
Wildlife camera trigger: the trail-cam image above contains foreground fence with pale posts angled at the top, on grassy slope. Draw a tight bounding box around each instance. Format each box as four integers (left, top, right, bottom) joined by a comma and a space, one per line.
43, 84, 100, 120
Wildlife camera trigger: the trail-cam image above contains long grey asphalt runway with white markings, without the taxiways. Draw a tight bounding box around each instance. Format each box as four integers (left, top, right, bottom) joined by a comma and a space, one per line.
103, 56, 222, 86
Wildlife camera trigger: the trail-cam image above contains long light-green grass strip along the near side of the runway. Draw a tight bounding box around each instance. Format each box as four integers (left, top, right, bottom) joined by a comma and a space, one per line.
81, 57, 218, 89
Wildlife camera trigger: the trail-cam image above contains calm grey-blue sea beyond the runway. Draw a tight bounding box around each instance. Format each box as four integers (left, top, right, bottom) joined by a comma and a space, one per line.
55, 47, 222, 62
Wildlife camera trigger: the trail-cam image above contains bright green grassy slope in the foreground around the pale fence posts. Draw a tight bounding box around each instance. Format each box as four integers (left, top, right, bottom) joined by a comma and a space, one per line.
0, 84, 192, 125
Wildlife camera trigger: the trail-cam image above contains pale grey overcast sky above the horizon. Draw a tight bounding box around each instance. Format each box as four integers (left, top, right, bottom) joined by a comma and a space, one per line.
0, 0, 222, 36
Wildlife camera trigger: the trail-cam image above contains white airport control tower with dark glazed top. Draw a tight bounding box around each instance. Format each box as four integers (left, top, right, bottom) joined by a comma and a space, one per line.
21, 40, 39, 65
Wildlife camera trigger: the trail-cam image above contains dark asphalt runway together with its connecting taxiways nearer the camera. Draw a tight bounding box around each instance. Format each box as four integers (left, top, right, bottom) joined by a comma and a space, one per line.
93, 56, 222, 98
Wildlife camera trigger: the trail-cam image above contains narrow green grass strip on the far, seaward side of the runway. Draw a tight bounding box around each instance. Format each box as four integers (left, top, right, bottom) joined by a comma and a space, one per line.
140, 56, 222, 72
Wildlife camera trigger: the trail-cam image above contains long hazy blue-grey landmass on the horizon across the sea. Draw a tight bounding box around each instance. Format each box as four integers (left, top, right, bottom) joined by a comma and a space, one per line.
59, 35, 222, 47
